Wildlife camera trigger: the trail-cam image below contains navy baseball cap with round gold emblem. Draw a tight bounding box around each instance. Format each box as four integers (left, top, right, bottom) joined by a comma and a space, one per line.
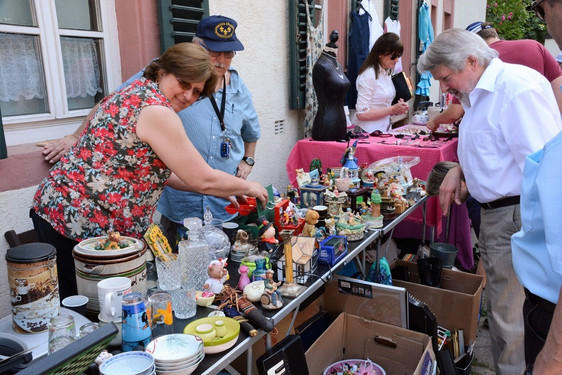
195, 16, 244, 52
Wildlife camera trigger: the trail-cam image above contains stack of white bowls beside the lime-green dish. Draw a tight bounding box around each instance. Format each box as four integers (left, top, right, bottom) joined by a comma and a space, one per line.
145, 333, 205, 375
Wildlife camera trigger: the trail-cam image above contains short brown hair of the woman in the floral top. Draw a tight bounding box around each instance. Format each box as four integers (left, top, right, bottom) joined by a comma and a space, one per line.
144, 43, 218, 96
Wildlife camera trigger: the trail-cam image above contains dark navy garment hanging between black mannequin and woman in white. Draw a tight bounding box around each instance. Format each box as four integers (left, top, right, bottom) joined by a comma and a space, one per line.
346, 12, 370, 109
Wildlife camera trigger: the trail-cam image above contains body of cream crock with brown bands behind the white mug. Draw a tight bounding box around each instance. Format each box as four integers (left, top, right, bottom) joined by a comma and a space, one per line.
72, 246, 148, 319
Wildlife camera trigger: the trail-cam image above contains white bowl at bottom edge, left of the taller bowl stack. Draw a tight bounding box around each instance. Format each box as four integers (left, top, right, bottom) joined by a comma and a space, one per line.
100, 351, 156, 375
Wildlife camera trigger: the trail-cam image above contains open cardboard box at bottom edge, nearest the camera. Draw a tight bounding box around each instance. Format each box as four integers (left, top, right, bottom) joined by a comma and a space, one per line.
306, 313, 435, 375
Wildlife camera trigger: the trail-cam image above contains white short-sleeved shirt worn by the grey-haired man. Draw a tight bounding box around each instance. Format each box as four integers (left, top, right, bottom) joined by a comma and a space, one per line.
457, 58, 562, 203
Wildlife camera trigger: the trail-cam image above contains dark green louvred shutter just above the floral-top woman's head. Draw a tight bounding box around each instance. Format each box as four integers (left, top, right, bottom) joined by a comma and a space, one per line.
158, 0, 209, 52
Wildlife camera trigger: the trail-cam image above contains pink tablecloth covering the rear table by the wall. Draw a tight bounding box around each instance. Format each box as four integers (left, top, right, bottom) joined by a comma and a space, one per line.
286, 137, 472, 268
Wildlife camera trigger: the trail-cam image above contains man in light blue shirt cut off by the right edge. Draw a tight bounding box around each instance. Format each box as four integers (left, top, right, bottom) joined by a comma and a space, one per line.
511, 0, 562, 374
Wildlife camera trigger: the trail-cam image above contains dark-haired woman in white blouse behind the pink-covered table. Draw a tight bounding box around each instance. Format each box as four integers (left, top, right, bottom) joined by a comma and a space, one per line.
355, 33, 409, 133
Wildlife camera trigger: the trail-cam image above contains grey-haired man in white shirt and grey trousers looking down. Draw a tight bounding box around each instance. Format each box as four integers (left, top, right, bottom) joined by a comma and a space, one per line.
418, 29, 562, 374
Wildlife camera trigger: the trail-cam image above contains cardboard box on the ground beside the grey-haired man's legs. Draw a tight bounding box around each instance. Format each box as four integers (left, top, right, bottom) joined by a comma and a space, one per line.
390, 260, 484, 345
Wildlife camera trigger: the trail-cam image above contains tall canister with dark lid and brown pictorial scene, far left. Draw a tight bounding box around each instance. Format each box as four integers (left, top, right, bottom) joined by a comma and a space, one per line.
6, 242, 60, 333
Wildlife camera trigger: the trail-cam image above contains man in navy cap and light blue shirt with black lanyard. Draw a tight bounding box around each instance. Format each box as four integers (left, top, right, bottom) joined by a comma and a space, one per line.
43, 15, 261, 248
